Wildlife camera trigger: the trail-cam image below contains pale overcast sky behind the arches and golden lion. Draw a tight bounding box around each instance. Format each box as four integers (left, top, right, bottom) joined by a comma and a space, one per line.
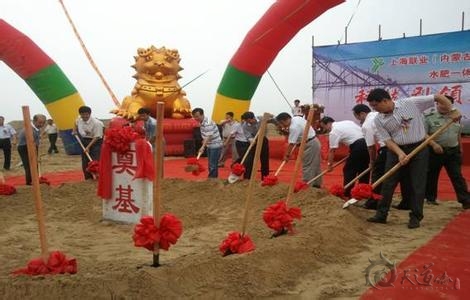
0, 0, 470, 122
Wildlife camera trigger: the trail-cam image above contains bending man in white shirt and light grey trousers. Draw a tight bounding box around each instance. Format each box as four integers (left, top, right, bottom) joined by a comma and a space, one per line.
276, 112, 322, 188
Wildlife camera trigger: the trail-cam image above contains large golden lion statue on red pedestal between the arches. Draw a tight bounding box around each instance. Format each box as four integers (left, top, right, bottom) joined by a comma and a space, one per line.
111, 46, 191, 120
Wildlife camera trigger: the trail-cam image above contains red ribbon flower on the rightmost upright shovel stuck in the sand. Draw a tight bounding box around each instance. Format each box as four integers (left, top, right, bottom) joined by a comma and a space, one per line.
263, 200, 302, 234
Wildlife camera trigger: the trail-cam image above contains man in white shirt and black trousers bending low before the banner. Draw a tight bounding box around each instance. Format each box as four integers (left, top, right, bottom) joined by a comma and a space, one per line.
320, 117, 370, 197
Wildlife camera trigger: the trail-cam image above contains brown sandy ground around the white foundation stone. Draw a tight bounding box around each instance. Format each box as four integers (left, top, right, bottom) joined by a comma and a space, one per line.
0, 137, 460, 299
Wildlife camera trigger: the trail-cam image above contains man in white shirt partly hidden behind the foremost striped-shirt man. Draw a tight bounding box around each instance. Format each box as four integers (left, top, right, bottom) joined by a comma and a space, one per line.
353, 104, 411, 210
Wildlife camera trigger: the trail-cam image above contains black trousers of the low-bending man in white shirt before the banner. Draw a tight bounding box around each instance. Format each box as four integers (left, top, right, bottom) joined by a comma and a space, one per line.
343, 139, 370, 198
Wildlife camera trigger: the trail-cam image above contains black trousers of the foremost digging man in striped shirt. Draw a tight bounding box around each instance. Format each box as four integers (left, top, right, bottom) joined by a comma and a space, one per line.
377, 142, 429, 220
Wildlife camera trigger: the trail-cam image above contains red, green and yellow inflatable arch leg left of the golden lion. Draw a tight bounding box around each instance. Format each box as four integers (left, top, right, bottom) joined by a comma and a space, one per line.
0, 19, 85, 154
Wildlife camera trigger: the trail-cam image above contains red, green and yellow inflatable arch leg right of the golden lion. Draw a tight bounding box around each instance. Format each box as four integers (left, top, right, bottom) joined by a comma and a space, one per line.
212, 0, 344, 120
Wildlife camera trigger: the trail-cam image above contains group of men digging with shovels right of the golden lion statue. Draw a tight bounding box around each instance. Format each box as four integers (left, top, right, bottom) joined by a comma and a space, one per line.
193, 88, 470, 229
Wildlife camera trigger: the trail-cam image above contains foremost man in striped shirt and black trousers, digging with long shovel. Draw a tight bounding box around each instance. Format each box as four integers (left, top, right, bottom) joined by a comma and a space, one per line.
367, 89, 460, 229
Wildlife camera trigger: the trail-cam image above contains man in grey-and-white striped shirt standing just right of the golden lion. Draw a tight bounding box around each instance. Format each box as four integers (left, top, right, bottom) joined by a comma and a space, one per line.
191, 108, 223, 178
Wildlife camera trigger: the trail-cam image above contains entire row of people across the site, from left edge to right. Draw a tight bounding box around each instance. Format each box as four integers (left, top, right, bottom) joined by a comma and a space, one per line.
0, 88, 470, 229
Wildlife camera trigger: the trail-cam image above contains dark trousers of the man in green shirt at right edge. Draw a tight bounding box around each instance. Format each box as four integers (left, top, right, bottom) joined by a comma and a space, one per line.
426, 146, 470, 203
